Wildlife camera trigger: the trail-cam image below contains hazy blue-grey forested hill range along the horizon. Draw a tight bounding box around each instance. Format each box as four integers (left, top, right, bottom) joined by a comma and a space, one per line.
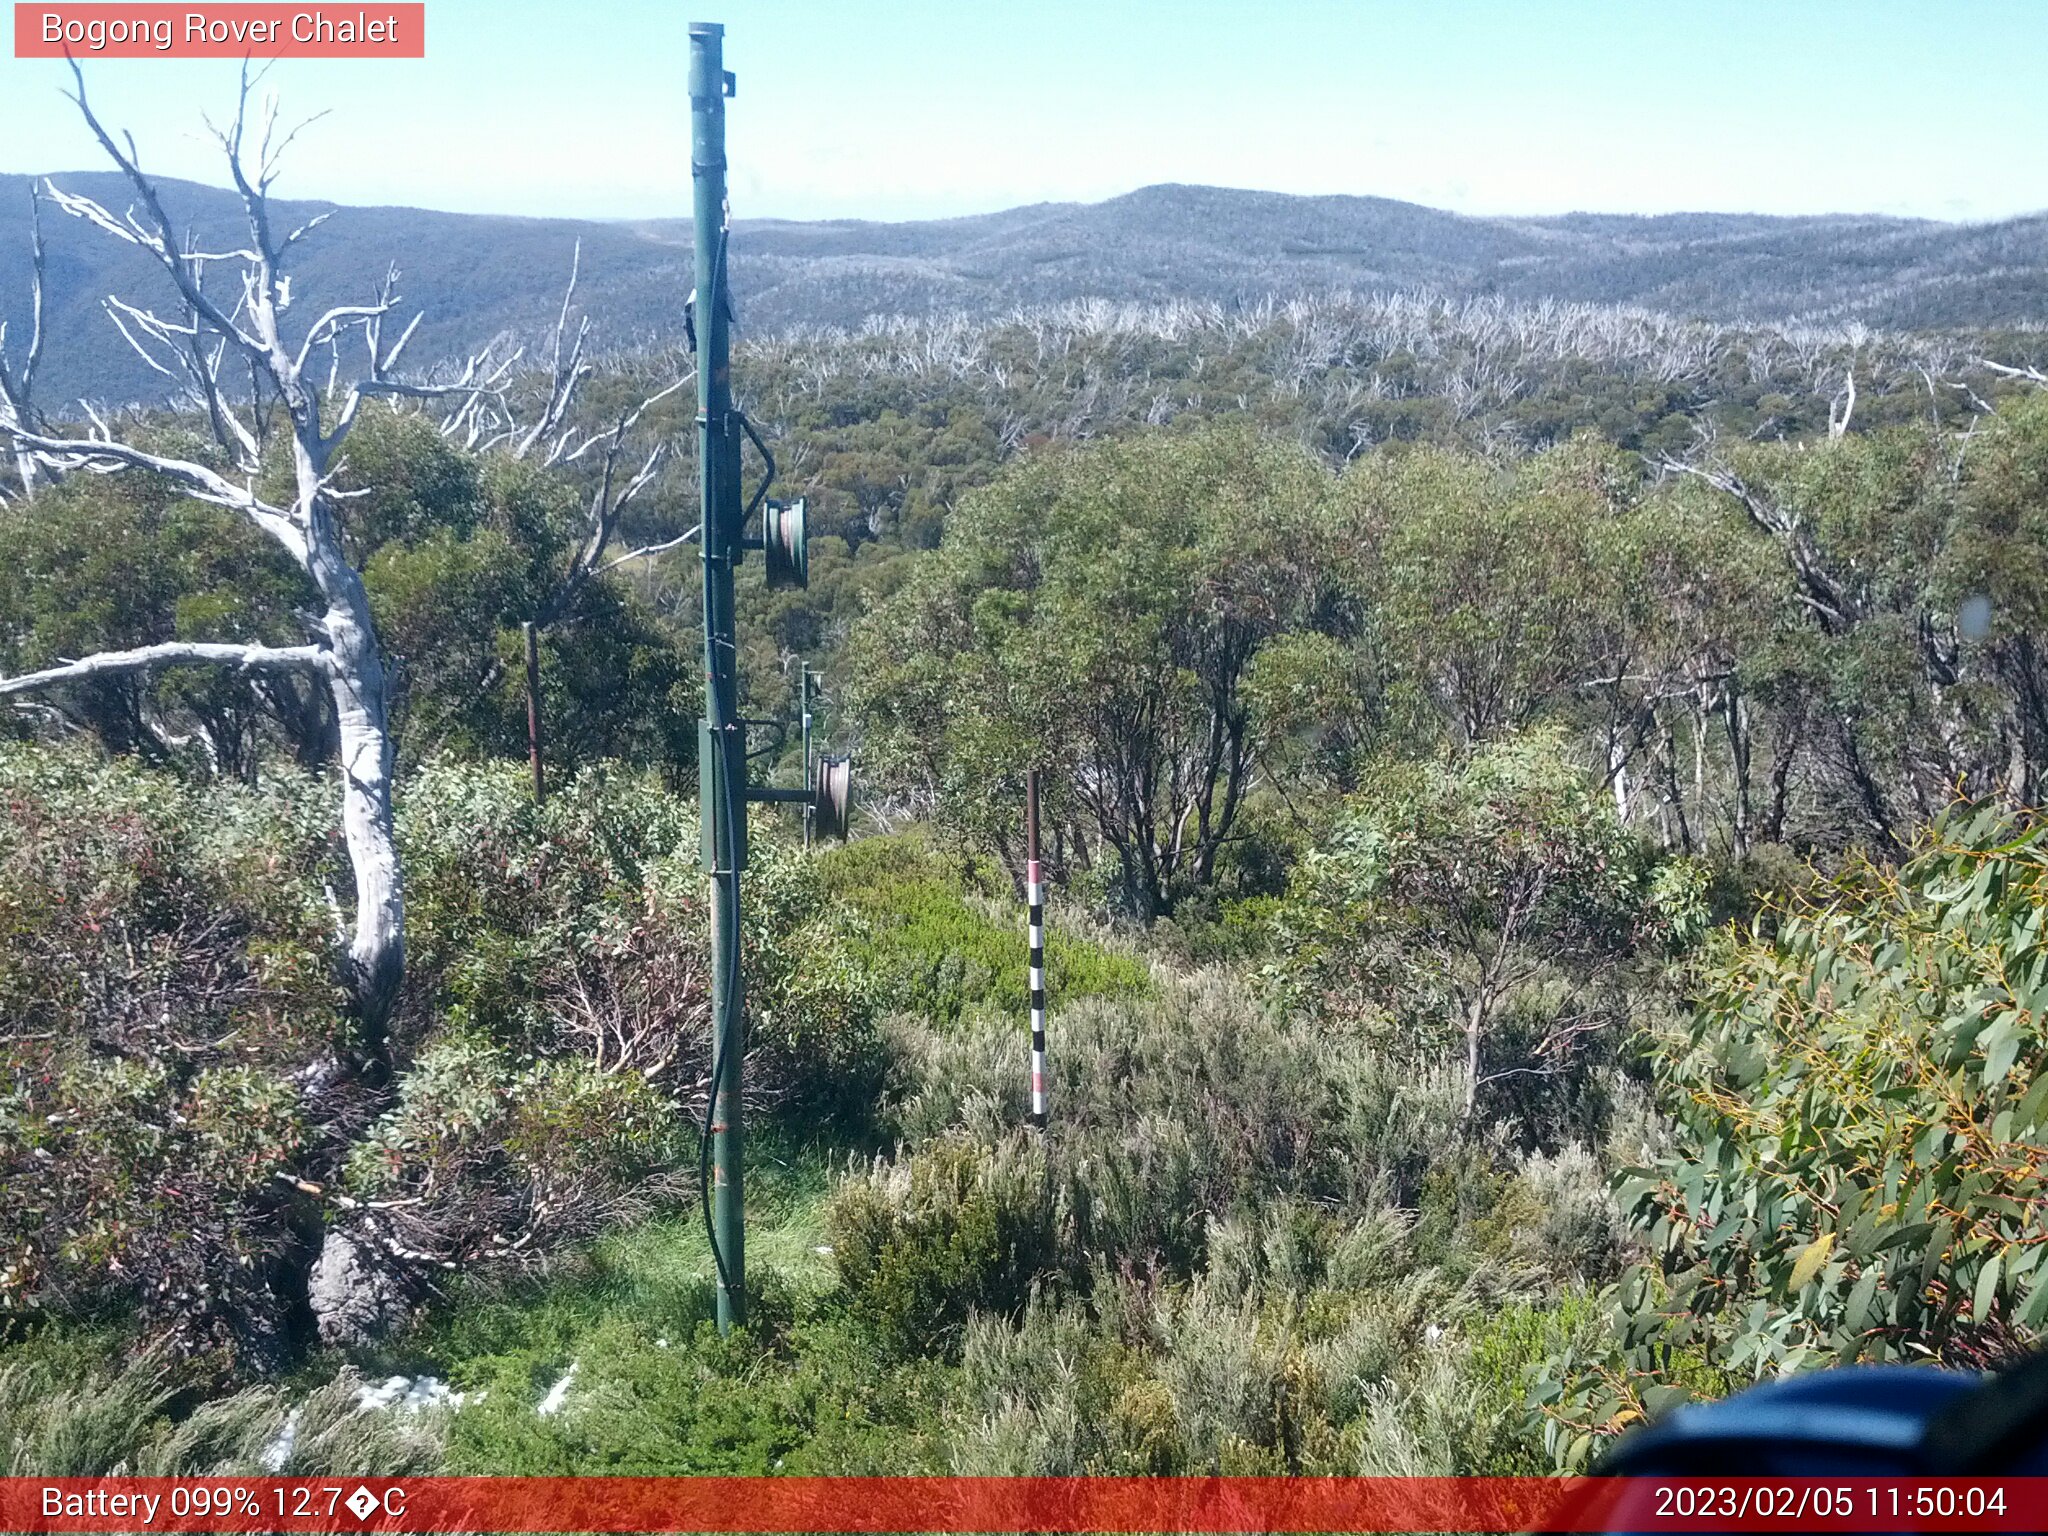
12, 172, 2048, 408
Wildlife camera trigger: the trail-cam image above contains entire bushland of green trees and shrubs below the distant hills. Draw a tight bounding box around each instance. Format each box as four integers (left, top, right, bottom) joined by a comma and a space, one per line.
0, 129, 2048, 1473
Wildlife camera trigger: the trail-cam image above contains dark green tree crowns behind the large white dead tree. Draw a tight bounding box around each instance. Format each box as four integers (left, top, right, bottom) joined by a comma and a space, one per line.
0, 406, 700, 780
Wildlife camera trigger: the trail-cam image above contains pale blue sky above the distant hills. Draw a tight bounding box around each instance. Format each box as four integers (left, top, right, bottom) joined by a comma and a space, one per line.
0, 0, 2048, 219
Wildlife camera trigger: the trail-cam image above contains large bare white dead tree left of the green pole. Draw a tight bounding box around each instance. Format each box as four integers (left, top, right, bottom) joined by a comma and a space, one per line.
0, 63, 496, 1081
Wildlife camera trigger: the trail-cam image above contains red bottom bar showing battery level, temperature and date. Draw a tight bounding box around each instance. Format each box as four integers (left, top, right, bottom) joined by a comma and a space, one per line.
0, 1477, 2048, 1532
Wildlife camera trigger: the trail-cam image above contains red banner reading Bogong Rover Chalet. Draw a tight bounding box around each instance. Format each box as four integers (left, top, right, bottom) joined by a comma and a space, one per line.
14, 4, 426, 59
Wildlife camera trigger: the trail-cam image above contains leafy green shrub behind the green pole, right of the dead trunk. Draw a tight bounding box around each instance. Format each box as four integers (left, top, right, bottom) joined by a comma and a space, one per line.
399, 764, 883, 1118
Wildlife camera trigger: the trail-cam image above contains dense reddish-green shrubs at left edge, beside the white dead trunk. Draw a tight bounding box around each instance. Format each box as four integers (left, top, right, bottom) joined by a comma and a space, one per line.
0, 748, 340, 1360
